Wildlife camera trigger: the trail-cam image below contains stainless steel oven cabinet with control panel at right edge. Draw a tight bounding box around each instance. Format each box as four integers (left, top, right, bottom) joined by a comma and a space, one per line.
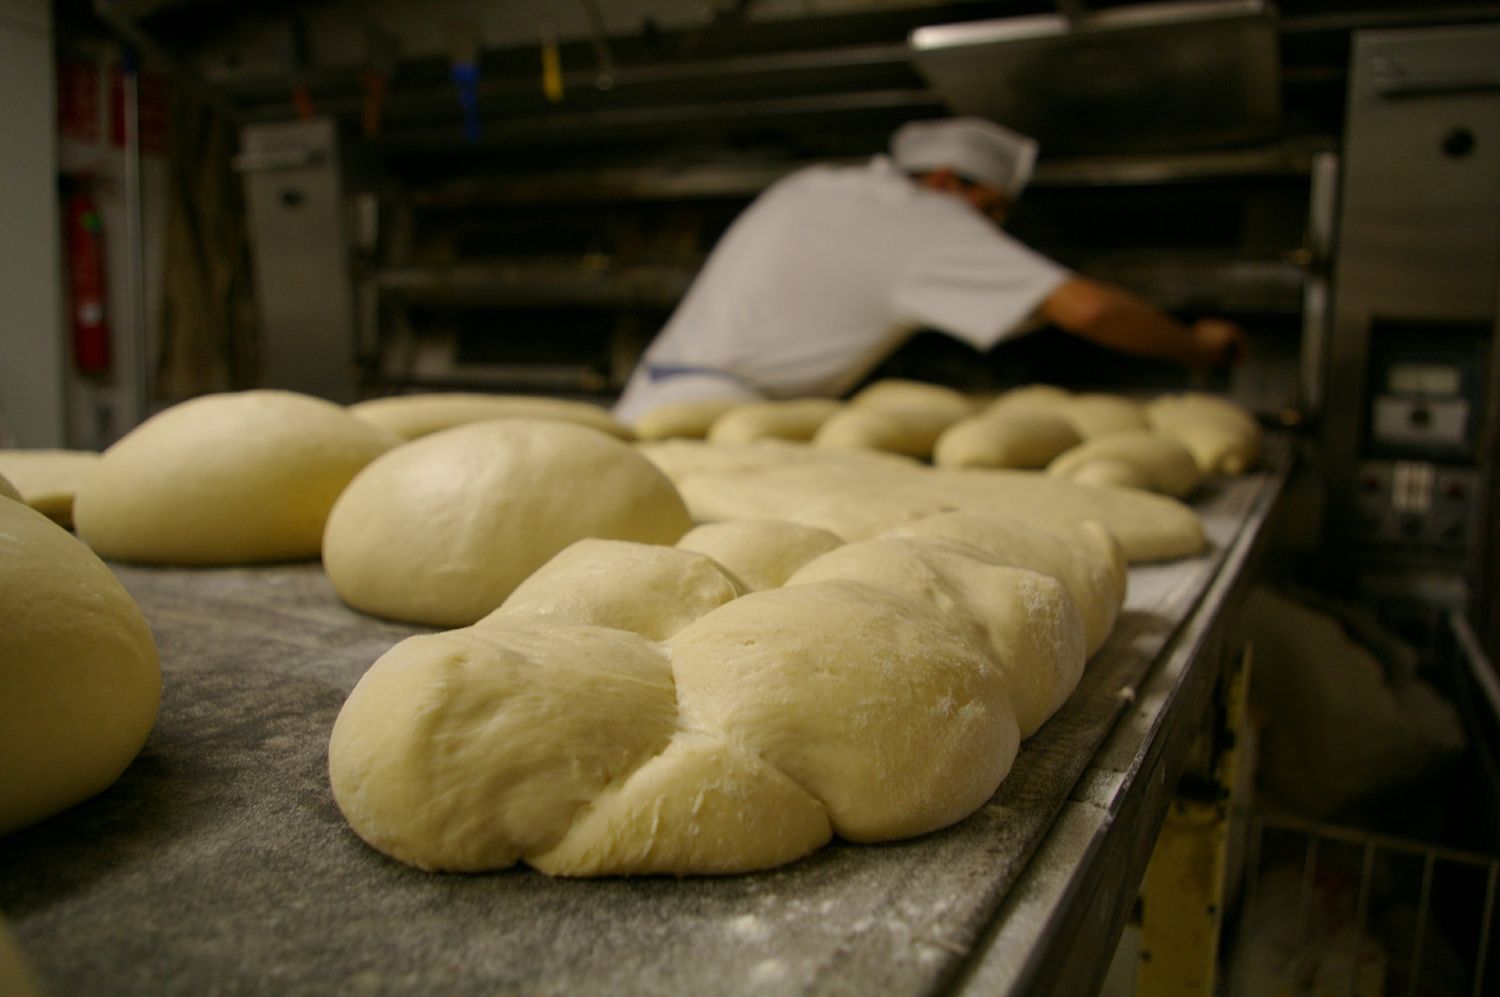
1320, 25, 1500, 653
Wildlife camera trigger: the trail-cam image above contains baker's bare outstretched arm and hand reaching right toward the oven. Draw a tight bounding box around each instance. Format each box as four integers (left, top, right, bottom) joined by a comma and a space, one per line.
1038, 277, 1245, 367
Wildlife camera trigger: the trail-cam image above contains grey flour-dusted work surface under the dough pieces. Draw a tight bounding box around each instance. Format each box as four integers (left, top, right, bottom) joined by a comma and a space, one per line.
0, 443, 1284, 994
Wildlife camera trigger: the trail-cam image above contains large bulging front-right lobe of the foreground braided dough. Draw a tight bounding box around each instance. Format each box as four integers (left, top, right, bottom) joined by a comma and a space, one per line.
668, 580, 1020, 841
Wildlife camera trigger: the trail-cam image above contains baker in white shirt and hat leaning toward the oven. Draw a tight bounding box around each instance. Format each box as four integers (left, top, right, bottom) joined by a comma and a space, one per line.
615, 118, 1245, 424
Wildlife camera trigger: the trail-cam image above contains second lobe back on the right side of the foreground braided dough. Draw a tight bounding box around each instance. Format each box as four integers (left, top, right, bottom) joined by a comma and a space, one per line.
786, 537, 1086, 738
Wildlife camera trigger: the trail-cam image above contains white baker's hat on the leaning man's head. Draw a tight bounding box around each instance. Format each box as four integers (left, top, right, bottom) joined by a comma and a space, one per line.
891, 117, 1037, 201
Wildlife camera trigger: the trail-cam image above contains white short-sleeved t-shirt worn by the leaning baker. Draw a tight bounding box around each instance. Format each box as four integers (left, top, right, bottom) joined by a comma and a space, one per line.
615, 156, 1068, 424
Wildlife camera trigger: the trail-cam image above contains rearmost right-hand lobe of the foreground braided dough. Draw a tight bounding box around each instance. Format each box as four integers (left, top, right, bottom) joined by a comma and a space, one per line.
890, 513, 1130, 655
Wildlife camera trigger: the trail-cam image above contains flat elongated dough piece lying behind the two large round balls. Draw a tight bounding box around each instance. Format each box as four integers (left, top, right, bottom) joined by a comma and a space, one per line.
350, 391, 632, 439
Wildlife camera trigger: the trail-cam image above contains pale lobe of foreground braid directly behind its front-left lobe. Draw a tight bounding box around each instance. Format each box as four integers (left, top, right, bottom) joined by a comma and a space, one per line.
476, 540, 746, 640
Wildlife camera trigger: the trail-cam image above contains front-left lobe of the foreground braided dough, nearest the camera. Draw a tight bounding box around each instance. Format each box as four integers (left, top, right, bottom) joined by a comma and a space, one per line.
329, 622, 677, 871
